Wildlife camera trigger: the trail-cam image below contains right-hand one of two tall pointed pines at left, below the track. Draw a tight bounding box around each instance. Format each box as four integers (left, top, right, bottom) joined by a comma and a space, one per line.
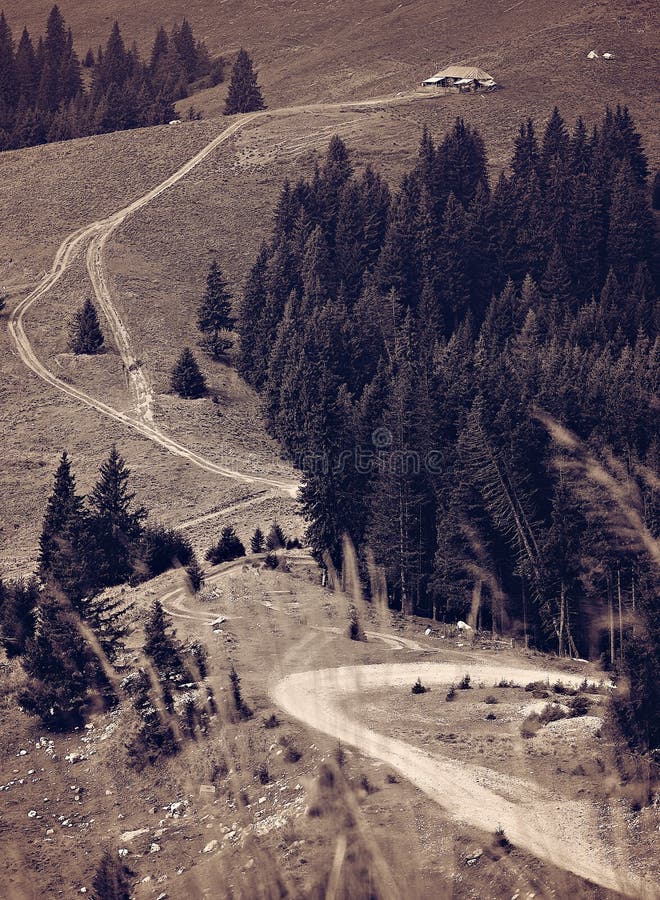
89, 445, 146, 586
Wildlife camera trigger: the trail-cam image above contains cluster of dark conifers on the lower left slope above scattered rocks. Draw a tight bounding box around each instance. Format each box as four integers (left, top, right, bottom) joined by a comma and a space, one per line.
0, 447, 206, 740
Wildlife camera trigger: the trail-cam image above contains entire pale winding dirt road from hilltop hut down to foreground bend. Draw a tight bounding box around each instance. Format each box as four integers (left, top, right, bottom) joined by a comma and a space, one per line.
8, 97, 650, 895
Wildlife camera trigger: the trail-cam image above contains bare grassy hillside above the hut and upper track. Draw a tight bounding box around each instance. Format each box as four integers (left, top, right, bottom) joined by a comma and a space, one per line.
7, 0, 657, 160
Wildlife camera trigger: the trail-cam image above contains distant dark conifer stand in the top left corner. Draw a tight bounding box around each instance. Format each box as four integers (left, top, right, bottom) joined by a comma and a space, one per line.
0, 6, 224, 150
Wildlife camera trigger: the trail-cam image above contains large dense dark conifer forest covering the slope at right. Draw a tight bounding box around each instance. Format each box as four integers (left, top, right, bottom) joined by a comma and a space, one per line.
238, 108, 659, 739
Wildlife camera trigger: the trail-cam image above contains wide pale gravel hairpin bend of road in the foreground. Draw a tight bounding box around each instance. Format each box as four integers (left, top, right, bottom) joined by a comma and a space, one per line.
271, 662, 652, 897
